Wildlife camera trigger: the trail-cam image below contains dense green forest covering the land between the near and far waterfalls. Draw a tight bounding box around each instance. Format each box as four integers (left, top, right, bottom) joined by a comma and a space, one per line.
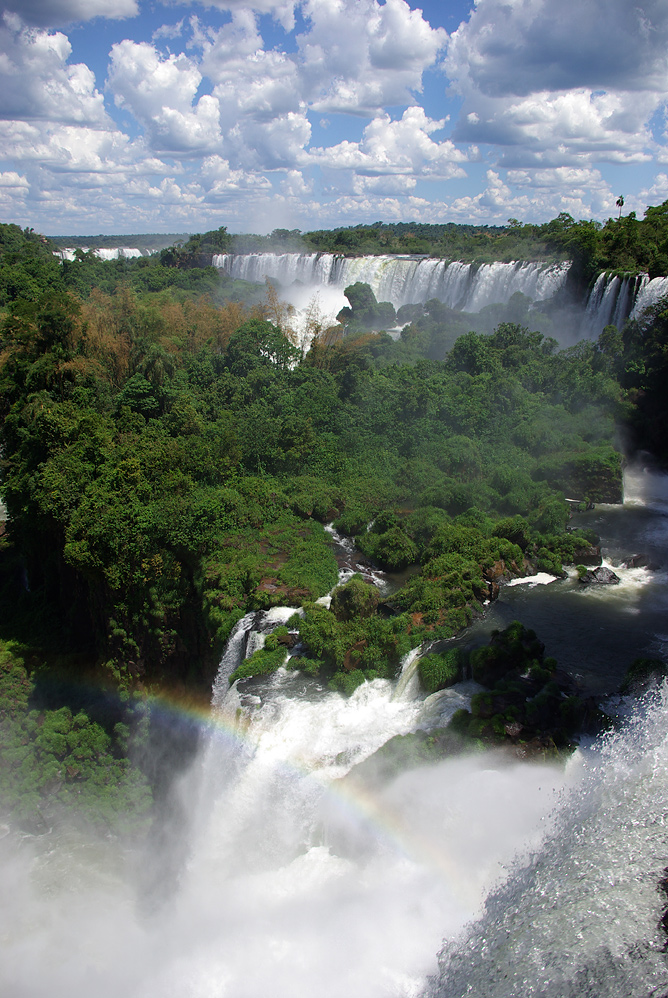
0, 213, 668, 836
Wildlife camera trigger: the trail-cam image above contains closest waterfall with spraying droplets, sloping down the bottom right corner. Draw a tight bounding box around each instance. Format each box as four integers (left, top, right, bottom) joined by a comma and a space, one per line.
428, 686, 668, 998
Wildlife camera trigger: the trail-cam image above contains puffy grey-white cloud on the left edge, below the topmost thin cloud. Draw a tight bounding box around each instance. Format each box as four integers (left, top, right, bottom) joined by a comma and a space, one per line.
0, 15, 107, 125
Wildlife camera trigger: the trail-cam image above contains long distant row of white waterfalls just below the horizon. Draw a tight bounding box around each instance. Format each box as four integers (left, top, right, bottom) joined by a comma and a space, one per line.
212, 253, 570, 312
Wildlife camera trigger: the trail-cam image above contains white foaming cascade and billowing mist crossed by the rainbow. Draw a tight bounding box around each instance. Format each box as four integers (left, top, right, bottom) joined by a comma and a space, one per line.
0, 674, 580, 998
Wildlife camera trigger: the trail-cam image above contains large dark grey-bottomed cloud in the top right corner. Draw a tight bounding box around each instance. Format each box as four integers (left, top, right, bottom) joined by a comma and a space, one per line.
445, 0, 668, 176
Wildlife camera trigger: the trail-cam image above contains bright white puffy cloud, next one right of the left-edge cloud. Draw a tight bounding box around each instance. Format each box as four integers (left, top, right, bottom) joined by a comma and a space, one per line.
108, 39, 221, 153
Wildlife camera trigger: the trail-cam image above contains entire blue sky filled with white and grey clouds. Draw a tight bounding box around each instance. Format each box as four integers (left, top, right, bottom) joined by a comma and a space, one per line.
0, 0, 668, 235
